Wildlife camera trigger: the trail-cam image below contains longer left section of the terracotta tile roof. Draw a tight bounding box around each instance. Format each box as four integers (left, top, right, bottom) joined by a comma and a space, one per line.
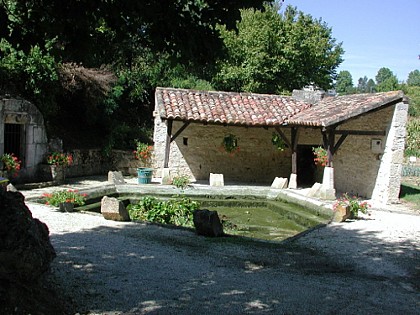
156, 88, 311, 126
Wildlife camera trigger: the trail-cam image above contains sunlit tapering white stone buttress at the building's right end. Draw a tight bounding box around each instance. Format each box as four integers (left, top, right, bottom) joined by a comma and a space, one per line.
372, 102, 408, 204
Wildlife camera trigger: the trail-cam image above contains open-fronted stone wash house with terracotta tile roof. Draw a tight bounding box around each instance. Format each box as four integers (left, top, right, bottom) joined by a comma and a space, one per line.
154, 88, 408, 203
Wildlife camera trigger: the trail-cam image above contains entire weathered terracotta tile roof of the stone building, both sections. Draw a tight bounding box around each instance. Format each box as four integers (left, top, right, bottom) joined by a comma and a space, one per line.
155, 88, 404, 126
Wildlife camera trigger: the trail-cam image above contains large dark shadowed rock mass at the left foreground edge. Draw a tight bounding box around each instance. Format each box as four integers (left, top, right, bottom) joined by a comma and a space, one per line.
0, 190, 56, 283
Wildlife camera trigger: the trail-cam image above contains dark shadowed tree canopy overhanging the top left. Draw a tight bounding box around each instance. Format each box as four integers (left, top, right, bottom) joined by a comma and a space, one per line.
0, 0, 270, 67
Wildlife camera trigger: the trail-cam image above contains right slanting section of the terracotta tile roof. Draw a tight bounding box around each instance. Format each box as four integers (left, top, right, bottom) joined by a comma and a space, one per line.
288, 91, 404, 127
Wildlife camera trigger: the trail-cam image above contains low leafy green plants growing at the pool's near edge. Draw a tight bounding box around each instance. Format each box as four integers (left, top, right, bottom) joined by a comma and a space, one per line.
127, 196, 200, 226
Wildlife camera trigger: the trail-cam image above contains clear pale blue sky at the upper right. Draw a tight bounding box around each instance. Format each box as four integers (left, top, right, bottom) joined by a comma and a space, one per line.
283, 0, 420, 85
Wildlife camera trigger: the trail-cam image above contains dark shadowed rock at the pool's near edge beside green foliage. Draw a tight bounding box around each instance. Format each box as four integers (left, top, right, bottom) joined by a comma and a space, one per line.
193, 209, 224, 237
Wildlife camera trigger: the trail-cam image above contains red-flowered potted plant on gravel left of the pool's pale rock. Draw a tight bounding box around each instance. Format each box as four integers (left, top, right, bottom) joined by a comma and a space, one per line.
42, 189, 87, 212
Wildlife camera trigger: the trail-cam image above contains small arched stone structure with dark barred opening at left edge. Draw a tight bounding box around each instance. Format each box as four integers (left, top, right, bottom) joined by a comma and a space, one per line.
0, 96, 48, 181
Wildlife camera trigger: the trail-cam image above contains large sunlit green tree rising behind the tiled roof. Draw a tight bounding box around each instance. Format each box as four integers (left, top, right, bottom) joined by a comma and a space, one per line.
213, 5, 343, 93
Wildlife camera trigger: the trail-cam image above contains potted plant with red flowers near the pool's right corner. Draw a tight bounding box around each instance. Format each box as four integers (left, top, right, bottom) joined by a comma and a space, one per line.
333, 193, 370, 222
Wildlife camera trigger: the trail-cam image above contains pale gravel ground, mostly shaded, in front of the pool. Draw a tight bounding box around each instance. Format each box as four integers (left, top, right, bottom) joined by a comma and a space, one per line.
28, 203, 420, 314
